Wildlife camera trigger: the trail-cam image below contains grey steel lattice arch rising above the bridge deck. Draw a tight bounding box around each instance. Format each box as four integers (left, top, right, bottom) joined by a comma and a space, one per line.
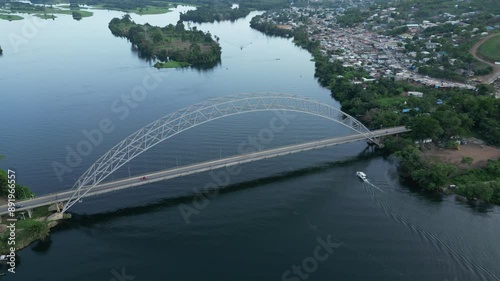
62, 93, 379, 212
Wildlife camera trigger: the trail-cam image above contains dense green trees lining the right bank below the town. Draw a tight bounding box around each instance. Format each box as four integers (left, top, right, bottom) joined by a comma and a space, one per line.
251, 16, 500, 204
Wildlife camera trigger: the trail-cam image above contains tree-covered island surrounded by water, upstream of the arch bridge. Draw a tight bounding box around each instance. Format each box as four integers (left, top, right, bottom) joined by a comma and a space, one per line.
109, 14, 222, 68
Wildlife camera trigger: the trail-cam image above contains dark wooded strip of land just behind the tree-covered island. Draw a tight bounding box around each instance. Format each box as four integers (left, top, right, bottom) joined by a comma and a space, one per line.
180, 4, 250, 23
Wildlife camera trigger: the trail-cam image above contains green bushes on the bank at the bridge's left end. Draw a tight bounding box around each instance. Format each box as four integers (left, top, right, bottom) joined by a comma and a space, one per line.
0, 167, 71, 254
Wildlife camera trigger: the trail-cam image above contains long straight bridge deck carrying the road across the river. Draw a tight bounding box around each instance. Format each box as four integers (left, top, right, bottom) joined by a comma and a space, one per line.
0, 127, 409, 215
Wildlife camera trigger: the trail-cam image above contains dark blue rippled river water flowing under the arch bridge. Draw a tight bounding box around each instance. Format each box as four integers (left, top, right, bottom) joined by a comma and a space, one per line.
0, 6, 500, 281
